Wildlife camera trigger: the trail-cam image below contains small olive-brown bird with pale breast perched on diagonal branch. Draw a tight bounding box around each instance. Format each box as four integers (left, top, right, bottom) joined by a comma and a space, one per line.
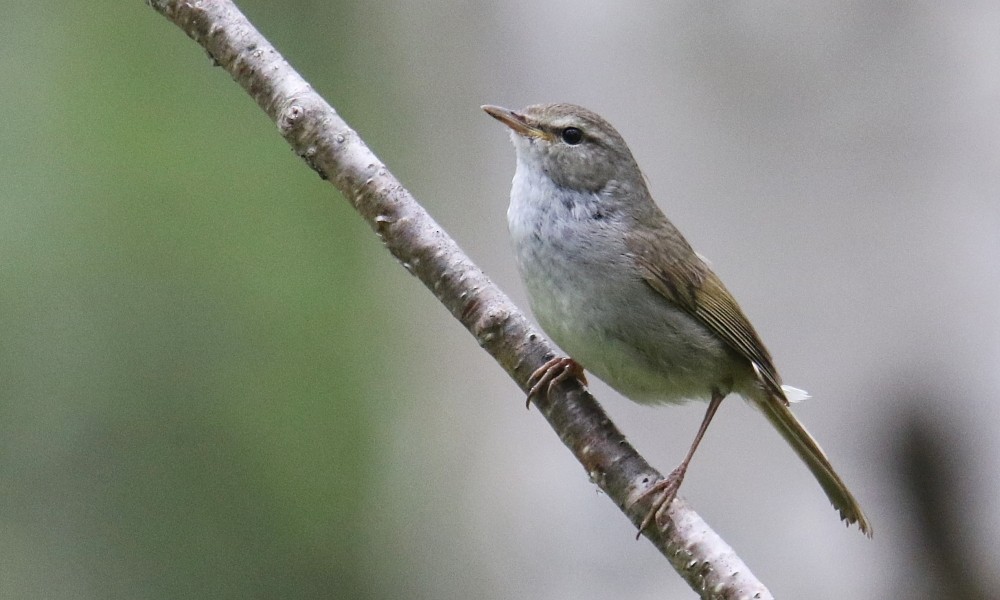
482, 103, 872, 537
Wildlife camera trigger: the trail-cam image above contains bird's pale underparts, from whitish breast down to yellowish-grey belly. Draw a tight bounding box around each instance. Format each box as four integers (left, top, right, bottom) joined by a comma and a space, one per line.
507, 154, 732, 402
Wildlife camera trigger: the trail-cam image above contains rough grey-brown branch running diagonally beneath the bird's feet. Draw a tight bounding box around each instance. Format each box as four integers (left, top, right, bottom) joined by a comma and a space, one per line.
148, 0, 772, 600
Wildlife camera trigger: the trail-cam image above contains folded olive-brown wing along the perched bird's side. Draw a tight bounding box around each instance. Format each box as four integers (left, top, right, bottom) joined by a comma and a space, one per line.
626, 225, 788, 404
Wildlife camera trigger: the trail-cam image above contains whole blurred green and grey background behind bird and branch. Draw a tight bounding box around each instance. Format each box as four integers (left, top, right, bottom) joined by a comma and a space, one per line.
0, 0, 1000, 600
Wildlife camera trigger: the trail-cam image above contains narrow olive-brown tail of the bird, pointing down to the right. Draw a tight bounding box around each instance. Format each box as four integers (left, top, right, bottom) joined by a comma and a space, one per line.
755, 392, 872, 537
